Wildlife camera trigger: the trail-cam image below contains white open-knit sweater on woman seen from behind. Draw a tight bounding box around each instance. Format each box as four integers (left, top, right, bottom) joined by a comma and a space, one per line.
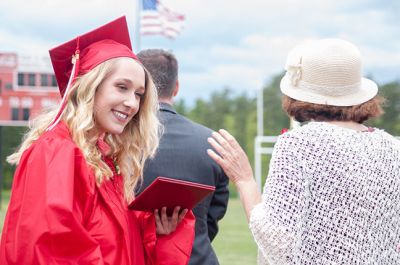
250, 122, 400, 265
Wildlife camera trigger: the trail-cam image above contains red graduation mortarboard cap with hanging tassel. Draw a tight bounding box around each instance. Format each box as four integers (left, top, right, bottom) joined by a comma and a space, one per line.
47, 16, 138, 130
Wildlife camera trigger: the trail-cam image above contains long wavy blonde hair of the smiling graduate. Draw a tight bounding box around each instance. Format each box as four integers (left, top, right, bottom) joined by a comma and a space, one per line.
7, 58, 161, 202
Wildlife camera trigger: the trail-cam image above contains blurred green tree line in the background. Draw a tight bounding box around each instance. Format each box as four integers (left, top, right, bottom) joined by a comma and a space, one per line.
1, 74, 400, 189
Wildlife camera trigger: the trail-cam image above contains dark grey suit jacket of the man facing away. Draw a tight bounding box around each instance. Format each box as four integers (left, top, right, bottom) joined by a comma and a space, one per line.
140, 103, 229, 265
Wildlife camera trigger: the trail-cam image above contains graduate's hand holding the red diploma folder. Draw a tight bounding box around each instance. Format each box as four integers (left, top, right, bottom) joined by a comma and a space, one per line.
154, 206, 188, 235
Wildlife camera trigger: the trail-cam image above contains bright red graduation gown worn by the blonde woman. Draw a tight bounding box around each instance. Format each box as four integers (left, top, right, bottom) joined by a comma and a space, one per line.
0, 123, 194, 265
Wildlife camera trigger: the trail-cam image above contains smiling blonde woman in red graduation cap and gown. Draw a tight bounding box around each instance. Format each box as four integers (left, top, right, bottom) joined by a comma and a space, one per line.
0, 17, 194, 265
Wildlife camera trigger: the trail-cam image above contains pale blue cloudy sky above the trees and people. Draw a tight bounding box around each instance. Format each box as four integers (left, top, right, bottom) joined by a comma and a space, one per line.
0, 0, 400, 104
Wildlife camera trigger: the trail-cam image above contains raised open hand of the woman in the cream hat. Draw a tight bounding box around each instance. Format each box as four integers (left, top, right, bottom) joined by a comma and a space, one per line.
207, 129, 253, 185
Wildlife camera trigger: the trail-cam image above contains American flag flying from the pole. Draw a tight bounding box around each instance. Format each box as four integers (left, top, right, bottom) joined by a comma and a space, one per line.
140, 0, 185, 38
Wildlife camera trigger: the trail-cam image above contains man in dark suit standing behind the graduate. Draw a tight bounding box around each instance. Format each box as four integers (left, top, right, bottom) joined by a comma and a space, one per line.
137, 49, 229, 265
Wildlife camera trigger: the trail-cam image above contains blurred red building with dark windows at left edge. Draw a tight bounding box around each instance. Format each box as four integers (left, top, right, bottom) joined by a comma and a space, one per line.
0, 52, 60, 124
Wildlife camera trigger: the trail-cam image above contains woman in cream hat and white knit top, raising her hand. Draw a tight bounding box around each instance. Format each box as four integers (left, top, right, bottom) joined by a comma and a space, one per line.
208, 39, 400, 265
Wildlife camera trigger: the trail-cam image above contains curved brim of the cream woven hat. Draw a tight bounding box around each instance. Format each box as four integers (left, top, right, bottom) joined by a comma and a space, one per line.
280, 75, 378, 107
